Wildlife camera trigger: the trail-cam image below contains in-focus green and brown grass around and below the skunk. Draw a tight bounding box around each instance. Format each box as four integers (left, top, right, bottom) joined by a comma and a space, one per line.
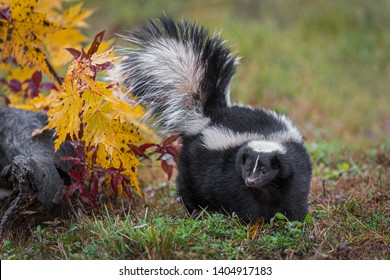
0, 145, 390, 259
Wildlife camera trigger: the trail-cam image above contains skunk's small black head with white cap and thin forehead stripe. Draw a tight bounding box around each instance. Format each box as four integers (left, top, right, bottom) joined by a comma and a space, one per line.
237, 141, 287, 188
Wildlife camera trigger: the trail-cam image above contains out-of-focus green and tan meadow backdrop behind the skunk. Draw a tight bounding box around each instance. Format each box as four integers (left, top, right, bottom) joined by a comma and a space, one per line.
85, 0, 390, 149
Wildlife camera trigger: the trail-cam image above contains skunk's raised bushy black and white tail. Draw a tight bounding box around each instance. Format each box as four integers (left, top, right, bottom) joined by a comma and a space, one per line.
111, 18, 238, 135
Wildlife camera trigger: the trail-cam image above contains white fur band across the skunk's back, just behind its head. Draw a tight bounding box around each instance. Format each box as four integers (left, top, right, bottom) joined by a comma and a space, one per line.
202, 127, 302, 150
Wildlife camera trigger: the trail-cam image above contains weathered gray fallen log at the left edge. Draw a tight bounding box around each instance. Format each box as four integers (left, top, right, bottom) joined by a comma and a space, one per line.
0, 107, 72, 239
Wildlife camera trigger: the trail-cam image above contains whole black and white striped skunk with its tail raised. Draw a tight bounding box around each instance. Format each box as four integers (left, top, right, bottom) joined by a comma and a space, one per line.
110, 17, 311, 221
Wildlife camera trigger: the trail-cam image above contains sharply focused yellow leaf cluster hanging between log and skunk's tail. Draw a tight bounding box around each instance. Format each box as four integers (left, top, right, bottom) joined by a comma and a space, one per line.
41, 31, 151, 196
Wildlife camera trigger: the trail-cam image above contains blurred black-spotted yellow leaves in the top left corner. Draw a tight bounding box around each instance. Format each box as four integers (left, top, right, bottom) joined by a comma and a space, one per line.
0, 0, 93, 78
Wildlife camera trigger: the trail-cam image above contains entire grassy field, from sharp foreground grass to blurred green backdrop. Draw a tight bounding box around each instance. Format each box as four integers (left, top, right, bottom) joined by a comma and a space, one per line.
0, 0, 390, 259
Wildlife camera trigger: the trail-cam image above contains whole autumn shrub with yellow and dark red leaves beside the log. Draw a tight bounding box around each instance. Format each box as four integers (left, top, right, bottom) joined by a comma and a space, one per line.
0, 0, 179, 208
